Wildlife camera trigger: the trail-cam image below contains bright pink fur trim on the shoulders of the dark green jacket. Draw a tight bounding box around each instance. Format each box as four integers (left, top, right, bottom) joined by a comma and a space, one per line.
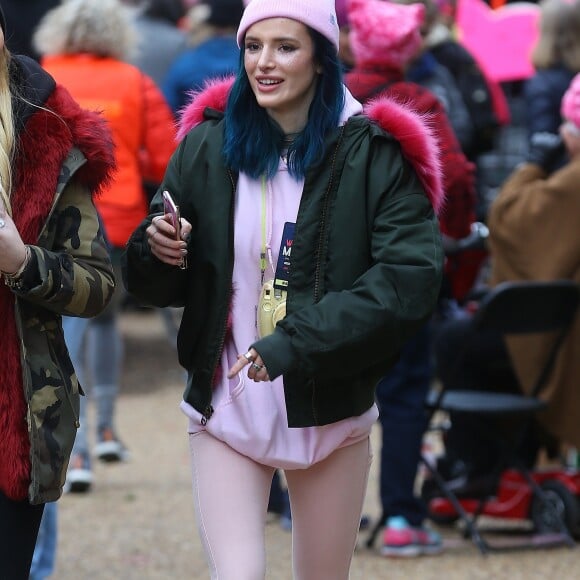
177, 78, 445, 213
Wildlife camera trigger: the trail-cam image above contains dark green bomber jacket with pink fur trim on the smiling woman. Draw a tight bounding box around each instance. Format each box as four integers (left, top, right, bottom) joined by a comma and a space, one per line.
124, 82, 443, 427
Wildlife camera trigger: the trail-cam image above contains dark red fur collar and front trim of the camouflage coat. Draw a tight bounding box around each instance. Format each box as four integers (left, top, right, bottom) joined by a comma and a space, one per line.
0, 87, 115, 500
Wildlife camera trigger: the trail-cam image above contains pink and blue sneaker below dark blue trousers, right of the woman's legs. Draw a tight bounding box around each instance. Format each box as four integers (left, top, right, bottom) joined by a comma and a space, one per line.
381, 516, 443, 558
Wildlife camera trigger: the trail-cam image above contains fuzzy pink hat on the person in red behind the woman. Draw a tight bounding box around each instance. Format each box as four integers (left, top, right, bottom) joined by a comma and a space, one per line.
347, 0, 425, 70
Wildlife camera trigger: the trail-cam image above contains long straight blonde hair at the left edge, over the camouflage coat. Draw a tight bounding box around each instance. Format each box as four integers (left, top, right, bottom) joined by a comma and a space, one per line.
0, 47, 15, 215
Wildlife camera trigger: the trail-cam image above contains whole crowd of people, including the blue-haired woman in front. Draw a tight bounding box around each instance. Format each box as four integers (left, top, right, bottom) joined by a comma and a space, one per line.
0, 0, 580, 580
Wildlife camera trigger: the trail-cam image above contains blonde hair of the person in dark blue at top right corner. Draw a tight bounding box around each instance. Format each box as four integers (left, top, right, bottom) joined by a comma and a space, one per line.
531, 0, 580, 72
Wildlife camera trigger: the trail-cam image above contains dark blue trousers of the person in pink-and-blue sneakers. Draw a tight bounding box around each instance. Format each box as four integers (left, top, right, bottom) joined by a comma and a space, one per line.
376, 324, 433, 526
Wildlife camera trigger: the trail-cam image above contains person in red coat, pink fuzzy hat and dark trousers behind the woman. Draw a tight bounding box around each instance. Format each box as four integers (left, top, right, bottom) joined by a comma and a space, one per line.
345, 0, 476, 556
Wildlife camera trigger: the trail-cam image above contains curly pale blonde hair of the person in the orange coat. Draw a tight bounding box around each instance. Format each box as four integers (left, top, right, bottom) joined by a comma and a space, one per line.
33, 0, 137, 60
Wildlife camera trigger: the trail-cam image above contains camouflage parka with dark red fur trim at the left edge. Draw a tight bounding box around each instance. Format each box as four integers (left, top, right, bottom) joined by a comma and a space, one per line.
0, 57, 115, 504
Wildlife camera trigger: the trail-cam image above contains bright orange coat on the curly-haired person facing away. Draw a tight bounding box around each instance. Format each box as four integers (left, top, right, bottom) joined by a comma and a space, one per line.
42, 54, 176, 247
